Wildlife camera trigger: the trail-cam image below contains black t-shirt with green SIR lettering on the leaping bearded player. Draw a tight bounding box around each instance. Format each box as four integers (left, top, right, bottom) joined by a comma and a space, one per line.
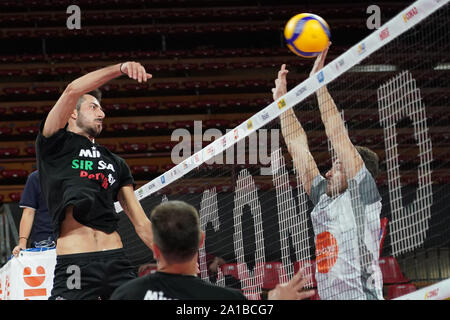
36, 121, 134, 238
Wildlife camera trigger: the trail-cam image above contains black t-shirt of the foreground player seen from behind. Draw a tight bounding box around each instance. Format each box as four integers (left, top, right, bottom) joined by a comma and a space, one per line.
111, 271, 246, 300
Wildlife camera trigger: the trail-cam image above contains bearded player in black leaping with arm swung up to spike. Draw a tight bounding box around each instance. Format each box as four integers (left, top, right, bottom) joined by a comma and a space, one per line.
36, 62, 153, 299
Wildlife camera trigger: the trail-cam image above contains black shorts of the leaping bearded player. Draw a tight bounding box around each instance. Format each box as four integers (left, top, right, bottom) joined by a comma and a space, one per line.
49, 248, 137, 300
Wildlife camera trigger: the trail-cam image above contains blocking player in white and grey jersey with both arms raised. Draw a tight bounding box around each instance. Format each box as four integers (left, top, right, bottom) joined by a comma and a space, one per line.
272, 48, 383, 300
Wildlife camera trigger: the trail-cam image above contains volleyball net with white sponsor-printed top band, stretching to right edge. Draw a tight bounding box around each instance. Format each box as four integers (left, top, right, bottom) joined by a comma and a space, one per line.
116, 0, 450, 299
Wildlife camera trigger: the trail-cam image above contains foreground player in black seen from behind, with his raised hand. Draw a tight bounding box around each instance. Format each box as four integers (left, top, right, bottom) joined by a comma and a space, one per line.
111, 201, 314, 300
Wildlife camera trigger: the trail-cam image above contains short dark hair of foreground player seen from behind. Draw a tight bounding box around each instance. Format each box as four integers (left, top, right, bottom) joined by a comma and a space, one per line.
150, 201, 201, 263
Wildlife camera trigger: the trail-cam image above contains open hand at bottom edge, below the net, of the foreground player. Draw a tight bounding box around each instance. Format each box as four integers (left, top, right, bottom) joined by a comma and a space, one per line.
269, 270, 315, 300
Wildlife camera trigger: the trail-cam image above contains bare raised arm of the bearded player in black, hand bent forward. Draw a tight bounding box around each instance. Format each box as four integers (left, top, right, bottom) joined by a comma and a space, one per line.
42, 61, 151, 137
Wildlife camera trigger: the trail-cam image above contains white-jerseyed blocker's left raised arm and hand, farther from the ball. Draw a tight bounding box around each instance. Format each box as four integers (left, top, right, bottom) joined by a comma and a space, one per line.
272, 64, 319, 195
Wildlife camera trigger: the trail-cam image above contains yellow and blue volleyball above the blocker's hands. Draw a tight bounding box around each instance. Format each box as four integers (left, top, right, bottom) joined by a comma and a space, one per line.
284, 13, 331, 58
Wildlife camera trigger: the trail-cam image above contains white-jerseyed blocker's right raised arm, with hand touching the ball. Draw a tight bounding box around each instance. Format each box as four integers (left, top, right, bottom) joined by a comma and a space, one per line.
311, 47, 364, 179
